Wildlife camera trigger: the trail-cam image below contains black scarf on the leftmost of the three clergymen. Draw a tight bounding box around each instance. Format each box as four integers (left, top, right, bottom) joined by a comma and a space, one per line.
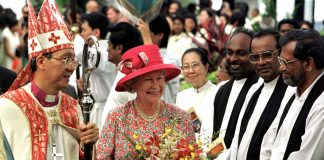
213, 73, 259, 148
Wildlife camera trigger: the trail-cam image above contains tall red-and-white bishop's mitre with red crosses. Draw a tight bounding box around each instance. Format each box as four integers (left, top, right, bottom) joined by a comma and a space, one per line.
9, 0, 73, 90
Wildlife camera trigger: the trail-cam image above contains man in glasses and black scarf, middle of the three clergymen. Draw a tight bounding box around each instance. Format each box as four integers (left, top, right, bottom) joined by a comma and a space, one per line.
230, 30, 294, 160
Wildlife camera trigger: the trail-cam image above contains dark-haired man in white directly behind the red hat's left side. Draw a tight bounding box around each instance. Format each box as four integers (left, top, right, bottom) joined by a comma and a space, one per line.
100, 22, 143, 128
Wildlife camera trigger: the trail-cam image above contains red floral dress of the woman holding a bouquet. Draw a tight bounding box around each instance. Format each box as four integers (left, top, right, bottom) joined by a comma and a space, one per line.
96, 101, 195, 160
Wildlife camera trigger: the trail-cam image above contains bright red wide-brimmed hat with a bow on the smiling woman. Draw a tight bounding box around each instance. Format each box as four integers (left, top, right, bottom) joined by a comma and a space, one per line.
116, 45, 181, 92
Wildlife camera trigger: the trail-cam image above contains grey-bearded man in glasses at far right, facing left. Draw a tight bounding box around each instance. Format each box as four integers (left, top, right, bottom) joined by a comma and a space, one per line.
261, 30, 324, 160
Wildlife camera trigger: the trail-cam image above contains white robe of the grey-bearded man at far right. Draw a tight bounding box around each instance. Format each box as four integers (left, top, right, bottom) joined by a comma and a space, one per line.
261, 73, 324, 160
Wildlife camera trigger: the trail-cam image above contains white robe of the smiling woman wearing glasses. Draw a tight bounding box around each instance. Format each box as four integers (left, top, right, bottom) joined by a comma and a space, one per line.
176, 81, 219, 148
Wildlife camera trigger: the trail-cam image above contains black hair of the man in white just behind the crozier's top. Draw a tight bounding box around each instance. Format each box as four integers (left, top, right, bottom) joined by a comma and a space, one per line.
81, 12, 109, 39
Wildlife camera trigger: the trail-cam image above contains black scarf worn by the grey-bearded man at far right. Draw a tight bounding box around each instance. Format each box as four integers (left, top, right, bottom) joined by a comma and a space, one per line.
278, 75, 324, 160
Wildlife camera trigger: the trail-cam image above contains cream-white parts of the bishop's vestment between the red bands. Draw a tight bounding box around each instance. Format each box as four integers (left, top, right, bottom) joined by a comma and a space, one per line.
0, 84, 83, 160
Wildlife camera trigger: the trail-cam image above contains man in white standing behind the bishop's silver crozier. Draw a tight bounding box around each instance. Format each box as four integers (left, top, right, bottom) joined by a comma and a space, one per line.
76, 12, 116, 126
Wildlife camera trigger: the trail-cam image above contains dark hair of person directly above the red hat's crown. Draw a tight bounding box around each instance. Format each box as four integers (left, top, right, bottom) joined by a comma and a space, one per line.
149, 15, 171, 48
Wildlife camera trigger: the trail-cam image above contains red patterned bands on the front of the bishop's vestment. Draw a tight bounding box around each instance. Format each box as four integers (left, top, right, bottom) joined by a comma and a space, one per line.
3, 88, 79, 160
